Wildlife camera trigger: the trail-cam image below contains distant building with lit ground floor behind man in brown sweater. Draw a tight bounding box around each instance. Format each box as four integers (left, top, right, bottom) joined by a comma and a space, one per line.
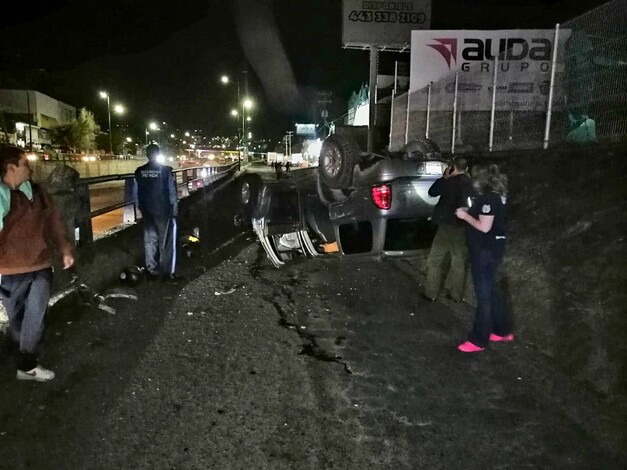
0, 90, 77, 150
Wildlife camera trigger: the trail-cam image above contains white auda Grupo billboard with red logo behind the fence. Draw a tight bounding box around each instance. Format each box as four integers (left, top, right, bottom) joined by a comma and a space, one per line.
409, 29, 570, 111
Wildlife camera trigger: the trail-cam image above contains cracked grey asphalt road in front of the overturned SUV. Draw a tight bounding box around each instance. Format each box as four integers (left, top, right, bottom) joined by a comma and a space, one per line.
0, 170, 627, 469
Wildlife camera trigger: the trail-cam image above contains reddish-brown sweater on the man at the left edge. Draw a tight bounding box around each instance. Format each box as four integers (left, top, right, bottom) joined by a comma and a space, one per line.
0, 183, 74, 274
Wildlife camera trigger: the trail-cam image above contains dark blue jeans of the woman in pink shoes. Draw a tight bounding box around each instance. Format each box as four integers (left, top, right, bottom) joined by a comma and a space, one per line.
468, 244, 512, 348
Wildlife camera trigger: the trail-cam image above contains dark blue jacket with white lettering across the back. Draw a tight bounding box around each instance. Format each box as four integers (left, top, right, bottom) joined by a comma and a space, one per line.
135, 162, 178, 217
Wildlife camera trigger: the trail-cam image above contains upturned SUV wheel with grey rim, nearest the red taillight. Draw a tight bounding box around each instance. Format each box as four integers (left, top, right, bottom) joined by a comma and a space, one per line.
318, 134, 359, 189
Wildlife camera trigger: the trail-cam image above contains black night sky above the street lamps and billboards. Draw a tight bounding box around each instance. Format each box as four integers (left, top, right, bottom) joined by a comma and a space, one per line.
0, 0, 606, 141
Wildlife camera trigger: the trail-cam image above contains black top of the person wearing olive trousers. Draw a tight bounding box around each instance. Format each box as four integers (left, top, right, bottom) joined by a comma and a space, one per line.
429, 173, 472, 227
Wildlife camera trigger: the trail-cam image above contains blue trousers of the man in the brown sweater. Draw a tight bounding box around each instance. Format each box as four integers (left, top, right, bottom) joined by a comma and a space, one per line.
0, 268, 52, 371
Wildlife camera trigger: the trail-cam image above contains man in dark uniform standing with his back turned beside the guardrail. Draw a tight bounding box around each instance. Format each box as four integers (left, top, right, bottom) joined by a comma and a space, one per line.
135, 144, 178, 280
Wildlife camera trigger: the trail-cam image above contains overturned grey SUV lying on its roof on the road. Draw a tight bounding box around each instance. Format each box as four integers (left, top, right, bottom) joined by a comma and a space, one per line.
241, 134, 447, 268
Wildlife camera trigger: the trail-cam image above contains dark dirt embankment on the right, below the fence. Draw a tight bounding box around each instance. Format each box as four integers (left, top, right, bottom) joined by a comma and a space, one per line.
488, 147, 627, 403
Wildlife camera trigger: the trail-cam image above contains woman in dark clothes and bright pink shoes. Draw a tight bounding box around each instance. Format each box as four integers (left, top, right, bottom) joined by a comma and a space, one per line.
455, 164, 514, 352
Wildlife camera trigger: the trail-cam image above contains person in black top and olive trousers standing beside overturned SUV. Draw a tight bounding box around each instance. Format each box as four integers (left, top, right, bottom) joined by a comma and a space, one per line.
422, 157, 472, 302
